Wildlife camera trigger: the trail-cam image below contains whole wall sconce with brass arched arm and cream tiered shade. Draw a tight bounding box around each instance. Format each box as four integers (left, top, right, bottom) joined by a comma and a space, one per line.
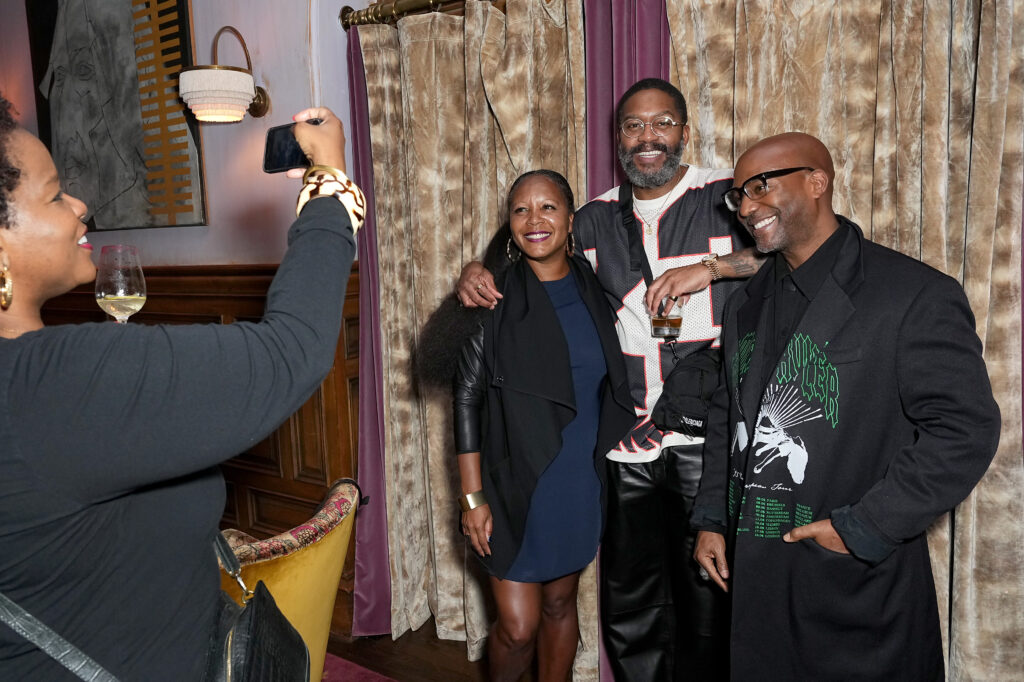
178, 26, 270, 123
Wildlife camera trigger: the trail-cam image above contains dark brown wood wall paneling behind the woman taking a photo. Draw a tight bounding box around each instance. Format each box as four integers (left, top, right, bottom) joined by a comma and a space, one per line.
43, 265, 359, 633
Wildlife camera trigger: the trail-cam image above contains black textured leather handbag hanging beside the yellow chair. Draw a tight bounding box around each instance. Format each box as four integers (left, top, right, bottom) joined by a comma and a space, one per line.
206, 532, 309, 682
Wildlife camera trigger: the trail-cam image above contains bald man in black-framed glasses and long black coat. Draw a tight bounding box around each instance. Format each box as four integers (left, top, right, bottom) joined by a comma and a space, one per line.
692, 133, 999, 681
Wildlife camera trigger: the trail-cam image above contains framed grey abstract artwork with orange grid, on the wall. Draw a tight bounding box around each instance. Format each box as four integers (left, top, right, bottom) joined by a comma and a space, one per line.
25, 0, 206, 230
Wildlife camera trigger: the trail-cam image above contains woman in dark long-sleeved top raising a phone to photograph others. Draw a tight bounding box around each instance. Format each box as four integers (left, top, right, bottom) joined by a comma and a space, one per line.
0, 96, 361, 681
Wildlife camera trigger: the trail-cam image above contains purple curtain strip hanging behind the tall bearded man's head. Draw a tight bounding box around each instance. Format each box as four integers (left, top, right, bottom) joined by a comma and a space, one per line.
584, 0, 671, 199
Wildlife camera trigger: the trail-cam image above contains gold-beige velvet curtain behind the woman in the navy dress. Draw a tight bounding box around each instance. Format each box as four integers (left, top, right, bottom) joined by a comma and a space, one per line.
359, 0, 597, 677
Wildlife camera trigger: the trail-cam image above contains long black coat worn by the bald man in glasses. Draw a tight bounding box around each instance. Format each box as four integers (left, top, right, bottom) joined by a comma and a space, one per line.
693, 218, 999, 680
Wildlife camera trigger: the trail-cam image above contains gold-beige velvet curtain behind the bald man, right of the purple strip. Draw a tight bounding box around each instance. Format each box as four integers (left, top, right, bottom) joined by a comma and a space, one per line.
667, 0, 1024, 680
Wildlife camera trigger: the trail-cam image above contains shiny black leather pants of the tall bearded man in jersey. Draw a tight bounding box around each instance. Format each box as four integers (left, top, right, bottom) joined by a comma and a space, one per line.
601, 445, 729, 682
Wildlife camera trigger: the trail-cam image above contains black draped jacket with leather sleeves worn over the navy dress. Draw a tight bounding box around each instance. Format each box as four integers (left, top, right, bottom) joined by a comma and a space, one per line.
454, 258, 636, 578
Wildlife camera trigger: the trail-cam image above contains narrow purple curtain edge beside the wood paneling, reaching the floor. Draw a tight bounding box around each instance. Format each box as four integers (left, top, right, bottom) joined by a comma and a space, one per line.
348, 27, 391, 637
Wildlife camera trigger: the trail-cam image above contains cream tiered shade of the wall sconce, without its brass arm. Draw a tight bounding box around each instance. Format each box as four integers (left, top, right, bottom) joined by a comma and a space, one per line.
178, 66, 256, 123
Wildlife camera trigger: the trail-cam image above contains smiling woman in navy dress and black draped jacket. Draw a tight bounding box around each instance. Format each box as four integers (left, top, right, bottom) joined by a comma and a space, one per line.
455, 170, 636, 682
